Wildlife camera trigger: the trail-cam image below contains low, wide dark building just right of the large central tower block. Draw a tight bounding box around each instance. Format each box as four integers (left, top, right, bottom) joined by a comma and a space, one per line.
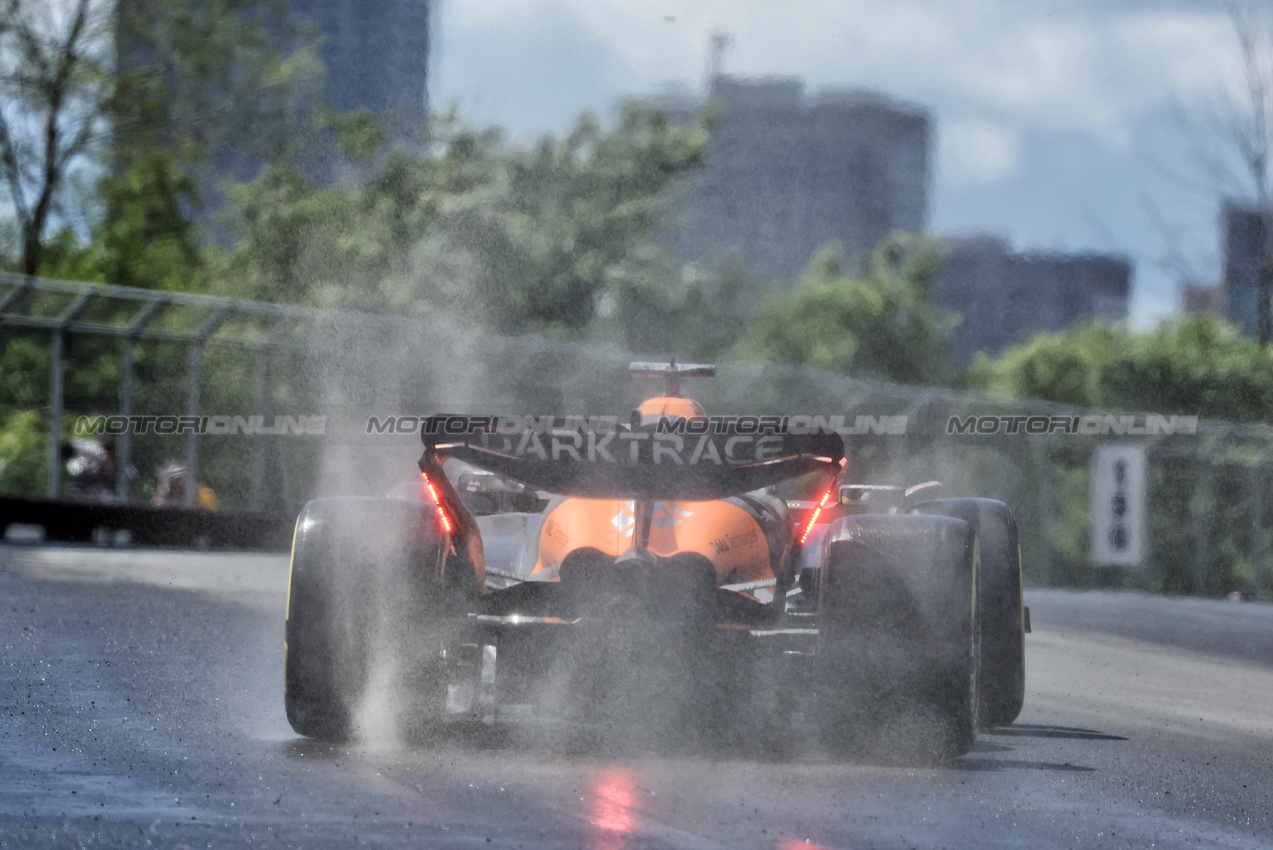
936, 235, 1132, 364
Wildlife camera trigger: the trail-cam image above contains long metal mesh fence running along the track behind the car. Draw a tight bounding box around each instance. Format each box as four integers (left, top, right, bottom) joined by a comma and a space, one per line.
0, 275, 1273, 598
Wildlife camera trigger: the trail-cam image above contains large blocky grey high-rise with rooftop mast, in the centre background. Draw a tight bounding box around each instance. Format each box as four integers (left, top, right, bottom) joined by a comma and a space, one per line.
663, 75, 929, 277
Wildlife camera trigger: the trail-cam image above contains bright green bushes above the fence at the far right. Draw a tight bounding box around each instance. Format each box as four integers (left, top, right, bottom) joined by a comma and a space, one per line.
966, 314, 1273, 422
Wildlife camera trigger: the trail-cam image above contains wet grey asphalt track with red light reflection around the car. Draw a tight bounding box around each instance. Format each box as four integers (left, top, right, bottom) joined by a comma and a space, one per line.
0, 546, 1273, 850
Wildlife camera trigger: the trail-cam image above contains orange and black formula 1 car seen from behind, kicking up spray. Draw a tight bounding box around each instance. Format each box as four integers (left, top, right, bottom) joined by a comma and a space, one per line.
285, 363, 1025, 762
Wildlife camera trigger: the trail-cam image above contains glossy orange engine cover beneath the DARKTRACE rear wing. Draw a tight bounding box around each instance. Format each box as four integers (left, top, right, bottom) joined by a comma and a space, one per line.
535, 499, 774, 584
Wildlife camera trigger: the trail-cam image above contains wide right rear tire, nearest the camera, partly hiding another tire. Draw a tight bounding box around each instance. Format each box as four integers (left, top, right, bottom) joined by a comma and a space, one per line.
816, 514, 978, 763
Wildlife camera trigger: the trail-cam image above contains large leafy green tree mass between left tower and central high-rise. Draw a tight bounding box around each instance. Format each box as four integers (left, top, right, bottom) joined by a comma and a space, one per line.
218, 103, 707, 337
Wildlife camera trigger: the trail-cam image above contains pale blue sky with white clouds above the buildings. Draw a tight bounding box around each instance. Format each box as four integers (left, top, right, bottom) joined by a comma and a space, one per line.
430, 0, 1257, 327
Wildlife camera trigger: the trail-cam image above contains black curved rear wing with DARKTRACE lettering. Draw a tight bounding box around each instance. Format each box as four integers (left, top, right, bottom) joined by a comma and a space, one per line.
420, 416, 844, 501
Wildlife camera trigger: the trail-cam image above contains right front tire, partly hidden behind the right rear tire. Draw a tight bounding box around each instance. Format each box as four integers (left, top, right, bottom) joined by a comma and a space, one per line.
911, 499, 1026, 730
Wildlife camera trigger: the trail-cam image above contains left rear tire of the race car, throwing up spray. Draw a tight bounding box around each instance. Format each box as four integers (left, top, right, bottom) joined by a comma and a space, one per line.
284, 499, 476, 741
